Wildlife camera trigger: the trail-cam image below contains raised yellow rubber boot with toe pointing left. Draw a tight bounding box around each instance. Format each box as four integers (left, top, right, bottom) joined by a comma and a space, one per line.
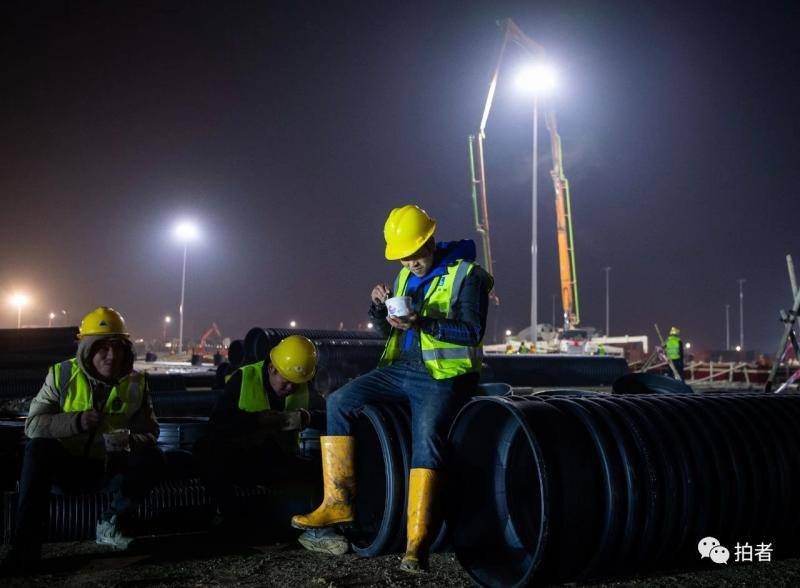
292, 435, 356, 530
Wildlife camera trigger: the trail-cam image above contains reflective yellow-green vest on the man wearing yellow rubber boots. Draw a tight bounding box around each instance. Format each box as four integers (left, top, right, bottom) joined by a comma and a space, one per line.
379, 259, 482, 380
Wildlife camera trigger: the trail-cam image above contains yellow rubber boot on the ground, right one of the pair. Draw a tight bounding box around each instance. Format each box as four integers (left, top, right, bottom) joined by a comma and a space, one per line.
400, 468, 440, 573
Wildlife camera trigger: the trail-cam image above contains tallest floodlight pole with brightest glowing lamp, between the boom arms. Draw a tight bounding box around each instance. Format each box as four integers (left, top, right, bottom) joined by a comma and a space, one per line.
517, 63, 556, 342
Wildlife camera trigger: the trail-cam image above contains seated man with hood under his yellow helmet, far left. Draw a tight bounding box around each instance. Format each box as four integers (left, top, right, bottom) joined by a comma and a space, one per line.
3, 306, 164, 573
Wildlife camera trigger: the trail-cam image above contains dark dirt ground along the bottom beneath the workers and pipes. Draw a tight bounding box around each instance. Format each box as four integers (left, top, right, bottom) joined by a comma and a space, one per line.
2, 535, 800, 588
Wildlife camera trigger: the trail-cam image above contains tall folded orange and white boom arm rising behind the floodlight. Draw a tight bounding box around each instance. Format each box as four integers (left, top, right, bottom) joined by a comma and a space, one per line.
469, 18, 580, 330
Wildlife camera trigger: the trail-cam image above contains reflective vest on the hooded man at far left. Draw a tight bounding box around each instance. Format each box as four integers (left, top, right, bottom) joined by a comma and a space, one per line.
53, 359, 144, 458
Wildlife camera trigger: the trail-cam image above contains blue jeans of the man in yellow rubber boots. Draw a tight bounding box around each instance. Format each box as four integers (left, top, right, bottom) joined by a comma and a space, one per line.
327, 363, 478, 469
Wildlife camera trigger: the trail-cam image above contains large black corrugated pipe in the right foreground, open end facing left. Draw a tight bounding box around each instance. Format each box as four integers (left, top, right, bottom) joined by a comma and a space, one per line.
446, 393, 800, 586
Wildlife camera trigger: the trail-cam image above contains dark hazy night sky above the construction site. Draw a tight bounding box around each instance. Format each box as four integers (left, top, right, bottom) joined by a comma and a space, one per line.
0, 0, 800, 352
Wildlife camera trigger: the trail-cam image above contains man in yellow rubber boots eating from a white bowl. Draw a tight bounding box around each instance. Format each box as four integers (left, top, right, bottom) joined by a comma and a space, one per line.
292, 205, 493, 572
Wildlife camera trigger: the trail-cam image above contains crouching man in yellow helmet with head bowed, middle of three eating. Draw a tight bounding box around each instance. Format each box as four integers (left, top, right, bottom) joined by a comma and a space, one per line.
196, 335, 332, 551
